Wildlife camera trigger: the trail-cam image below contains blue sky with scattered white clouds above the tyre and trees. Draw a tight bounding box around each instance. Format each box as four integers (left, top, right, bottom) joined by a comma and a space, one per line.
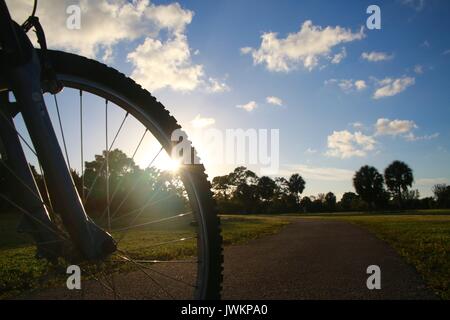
9, 0, 450, 196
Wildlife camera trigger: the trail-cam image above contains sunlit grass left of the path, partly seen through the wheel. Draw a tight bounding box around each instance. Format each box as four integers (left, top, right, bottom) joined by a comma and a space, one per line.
0, 214, 288, 299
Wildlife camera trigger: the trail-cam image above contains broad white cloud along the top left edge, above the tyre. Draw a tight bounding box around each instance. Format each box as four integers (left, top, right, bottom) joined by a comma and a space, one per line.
8, 0, 193, 57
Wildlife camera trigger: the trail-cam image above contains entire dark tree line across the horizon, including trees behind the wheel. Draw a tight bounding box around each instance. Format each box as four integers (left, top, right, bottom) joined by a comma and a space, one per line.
0, 149, 450, 218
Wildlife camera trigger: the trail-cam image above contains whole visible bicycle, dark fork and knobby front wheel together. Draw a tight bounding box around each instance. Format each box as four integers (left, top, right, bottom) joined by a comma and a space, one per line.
0, 0, 223, 299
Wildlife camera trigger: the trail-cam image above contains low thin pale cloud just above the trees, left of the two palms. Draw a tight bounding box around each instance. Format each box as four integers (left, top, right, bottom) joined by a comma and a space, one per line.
280, 164, 355, 181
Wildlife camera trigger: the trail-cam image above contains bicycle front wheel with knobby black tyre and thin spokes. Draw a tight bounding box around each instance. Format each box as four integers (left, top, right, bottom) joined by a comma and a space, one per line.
0, 51, 223, 299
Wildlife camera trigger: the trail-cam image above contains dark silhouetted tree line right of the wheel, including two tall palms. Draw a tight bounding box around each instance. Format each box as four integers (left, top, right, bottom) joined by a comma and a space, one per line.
212, 161, 450, 214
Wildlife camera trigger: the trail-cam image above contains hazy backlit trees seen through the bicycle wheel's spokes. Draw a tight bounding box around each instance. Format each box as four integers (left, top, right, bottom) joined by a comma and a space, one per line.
82, 149, 187, 218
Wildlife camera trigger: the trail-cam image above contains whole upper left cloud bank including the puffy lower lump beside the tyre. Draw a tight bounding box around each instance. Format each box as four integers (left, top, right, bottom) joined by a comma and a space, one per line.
8, 0, 229, 92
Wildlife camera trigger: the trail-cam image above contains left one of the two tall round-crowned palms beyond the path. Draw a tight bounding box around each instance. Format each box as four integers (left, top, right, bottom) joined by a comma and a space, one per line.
353, 165, 385, 209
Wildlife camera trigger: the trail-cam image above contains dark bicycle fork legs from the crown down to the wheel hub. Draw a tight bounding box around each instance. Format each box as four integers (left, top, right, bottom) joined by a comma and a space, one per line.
0, 50, 116, 260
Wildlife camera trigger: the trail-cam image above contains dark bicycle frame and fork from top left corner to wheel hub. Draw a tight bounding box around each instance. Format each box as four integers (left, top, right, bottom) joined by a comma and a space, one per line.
0, 0, 115, 260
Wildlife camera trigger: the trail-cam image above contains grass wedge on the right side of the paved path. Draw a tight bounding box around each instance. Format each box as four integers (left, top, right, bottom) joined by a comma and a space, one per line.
304, 210, 450, 300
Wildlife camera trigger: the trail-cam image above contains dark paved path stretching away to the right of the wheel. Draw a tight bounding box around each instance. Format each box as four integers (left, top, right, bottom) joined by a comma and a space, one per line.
224, 219, 435, 299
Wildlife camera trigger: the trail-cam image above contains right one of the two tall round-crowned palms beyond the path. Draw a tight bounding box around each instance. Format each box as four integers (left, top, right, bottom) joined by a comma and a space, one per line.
384, 160, 414, 206
